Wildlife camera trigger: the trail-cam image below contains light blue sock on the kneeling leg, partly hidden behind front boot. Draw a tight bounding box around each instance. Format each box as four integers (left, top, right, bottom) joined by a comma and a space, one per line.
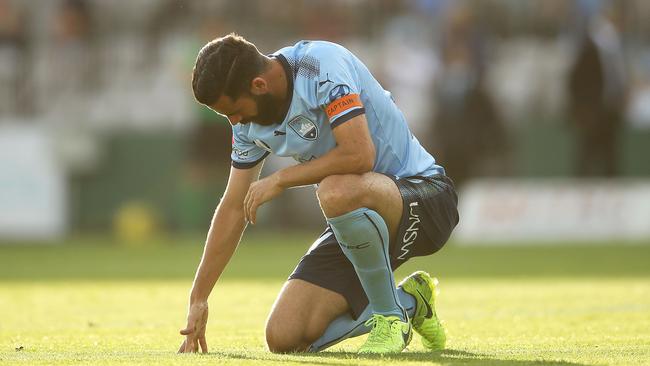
307, 288, 415, 352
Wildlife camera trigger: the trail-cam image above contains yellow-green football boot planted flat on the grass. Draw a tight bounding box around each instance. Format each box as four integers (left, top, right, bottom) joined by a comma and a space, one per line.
359, 314, 413, 354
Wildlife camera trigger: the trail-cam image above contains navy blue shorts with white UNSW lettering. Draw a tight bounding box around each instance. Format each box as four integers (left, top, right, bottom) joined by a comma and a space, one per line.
289, 175, 458, 319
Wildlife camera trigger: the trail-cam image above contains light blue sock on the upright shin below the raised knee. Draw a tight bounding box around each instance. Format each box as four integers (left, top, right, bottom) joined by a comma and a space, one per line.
327, 207, 406, 320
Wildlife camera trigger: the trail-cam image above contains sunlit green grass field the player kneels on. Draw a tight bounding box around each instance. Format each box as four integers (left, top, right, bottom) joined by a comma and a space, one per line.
0, 233, 650, 366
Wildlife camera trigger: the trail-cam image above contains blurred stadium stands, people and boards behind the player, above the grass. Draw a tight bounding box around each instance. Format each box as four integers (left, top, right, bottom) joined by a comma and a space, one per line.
0, 0, 650, 242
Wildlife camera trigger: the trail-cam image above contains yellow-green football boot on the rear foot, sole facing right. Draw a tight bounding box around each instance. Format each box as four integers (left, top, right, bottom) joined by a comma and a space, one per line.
398, 271, 447, 351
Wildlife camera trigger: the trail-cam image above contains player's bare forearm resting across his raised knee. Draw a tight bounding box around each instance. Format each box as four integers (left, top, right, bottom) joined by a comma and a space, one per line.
275, 147, 374, 188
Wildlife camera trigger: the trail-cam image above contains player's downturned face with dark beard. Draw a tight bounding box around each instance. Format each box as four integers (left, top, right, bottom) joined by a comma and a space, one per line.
210, 93, 284, 126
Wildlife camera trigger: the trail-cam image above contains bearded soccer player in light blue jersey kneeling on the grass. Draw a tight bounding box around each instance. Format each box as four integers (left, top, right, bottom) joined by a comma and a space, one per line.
179, 34, 458, 354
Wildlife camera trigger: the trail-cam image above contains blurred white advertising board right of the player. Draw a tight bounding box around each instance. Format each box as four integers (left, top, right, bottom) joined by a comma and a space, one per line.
456, 179, 650, 244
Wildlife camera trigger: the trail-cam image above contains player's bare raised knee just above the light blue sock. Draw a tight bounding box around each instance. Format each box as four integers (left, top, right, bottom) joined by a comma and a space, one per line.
316, 174, 366, 217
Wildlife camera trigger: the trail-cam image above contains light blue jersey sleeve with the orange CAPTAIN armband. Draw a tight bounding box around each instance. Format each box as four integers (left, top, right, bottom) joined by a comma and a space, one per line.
317, 50, 366, 129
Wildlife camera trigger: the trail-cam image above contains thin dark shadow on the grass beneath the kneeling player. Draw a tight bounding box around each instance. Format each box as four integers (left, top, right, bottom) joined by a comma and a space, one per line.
211, 350, 585, 366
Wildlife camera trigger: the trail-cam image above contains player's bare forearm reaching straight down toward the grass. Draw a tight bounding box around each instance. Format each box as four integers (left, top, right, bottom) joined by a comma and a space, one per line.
190, 203, 246, 303
